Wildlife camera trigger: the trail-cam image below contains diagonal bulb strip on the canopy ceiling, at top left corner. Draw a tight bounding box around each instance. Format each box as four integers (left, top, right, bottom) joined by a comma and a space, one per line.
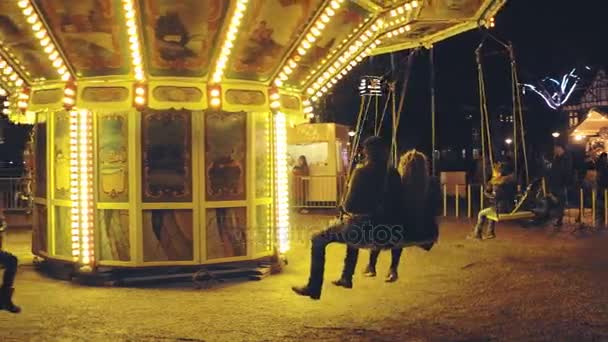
17, 0, 72, 81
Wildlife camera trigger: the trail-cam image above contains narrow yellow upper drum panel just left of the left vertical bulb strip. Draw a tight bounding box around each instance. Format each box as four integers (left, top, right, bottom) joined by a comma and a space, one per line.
53, 111, 70, 200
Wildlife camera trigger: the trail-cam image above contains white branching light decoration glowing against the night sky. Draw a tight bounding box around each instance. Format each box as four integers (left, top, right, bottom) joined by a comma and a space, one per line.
523, 68, 589, 109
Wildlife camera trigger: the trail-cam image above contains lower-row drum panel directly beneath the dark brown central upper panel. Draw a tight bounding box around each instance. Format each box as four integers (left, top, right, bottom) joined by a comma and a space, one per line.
143, 210, 194, 261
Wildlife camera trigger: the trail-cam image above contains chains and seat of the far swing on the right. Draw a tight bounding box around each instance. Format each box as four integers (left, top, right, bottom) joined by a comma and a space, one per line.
475, 31, 536, 222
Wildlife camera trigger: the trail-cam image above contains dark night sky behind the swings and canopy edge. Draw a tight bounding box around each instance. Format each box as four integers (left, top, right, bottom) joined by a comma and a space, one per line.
326, 0, 608, 160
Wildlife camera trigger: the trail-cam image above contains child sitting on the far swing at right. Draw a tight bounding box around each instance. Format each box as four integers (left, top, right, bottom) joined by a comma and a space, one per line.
467, 163, 517, 240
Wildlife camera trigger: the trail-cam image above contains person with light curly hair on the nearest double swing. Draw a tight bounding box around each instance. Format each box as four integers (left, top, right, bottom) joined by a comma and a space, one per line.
363, 149, 441, 283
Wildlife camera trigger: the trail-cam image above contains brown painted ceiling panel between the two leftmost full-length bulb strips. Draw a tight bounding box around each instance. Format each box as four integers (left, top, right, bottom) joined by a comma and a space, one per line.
36, 0, 129, 77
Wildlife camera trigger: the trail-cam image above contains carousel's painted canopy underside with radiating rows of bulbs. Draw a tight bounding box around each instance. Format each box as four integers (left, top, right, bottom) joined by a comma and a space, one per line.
0, 0, 506, 108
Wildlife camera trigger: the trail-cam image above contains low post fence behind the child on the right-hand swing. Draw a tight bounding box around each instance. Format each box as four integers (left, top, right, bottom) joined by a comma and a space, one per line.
441, 184, 608, 226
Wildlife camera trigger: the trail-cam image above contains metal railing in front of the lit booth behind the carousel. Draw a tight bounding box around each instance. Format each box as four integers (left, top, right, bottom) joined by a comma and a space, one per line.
290, 176, 346, 209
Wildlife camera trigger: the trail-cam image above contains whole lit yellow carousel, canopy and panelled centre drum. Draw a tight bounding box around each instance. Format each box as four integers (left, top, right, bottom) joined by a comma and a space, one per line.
0, 0, 506, 282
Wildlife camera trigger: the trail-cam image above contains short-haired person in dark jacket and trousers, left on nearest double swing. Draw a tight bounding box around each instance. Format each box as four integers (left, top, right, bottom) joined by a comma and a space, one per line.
292, 136, 402, 299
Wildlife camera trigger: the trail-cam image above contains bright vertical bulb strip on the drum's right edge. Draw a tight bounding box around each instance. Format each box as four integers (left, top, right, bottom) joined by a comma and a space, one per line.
274, 111, 289, 253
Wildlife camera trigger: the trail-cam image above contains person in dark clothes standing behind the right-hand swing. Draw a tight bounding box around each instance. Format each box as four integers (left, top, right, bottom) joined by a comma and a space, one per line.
548, 143, 574, 227
